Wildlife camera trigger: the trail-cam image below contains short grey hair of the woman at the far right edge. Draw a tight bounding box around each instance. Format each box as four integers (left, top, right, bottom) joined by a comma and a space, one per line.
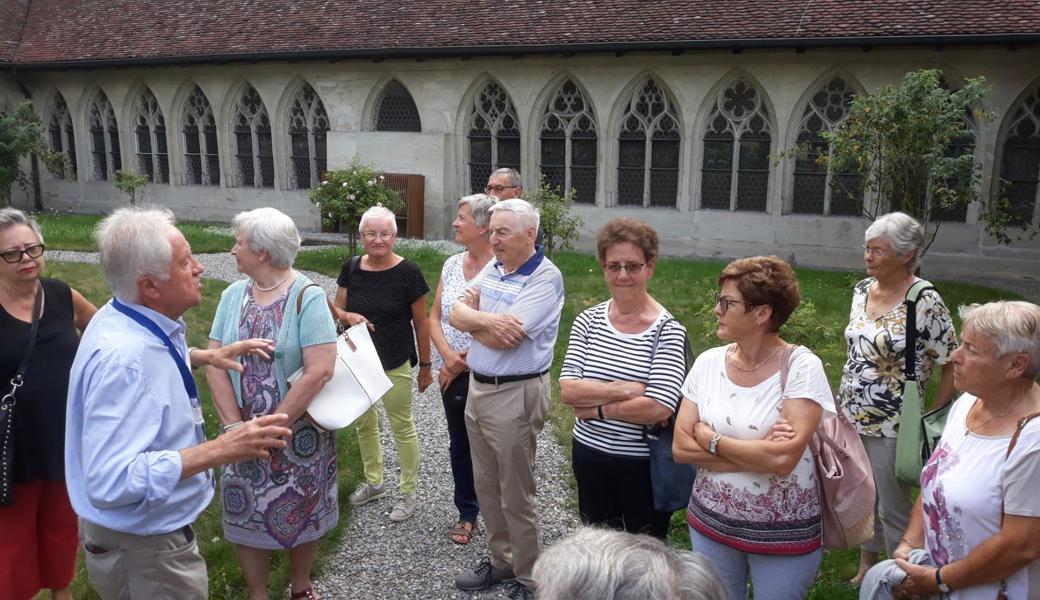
958, 301, 1040, 379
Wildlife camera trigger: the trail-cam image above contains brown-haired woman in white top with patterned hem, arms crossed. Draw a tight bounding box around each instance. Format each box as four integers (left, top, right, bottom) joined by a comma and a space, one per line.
673, 257, 834, 600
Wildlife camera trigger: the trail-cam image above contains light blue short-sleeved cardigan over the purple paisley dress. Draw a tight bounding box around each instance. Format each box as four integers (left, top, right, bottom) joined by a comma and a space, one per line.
202, 275, 336, 407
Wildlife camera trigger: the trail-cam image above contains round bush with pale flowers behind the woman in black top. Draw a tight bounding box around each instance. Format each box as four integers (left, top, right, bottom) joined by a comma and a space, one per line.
310, 156, 405, 256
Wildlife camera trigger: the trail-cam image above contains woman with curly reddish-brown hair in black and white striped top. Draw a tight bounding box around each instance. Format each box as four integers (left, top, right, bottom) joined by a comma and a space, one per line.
560, 218, 685, 539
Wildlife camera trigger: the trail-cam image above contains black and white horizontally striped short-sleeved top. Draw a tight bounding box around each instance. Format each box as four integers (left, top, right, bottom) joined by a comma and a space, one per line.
560, 301, 686, 458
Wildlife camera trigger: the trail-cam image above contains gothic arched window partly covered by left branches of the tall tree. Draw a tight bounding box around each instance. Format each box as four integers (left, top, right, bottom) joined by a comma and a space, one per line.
791, 77, 863, 215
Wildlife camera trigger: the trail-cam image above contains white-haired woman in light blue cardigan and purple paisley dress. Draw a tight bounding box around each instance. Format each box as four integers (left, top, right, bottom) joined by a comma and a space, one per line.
206, 208, 339, 600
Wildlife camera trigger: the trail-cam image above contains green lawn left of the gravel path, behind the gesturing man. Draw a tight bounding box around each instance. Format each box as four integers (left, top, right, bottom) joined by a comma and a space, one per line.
44, 263, 361, 599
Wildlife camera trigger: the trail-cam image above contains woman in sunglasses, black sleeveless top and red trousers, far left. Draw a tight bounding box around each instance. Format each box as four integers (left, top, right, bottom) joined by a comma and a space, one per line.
0, 208, 97, 600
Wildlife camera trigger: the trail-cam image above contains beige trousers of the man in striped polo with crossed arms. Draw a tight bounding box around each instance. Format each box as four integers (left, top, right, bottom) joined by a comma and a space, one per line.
466, 373, 551, 590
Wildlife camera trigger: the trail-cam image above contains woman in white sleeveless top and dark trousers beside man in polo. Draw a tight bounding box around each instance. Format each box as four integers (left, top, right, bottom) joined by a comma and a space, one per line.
430, 193, 495, 544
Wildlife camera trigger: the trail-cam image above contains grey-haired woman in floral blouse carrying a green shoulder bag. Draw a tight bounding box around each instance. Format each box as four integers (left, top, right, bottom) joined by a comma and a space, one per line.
838, 212, 957, 584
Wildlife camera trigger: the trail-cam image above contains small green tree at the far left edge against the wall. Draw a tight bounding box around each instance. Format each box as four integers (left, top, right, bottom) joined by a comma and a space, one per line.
0, 100, 68, 208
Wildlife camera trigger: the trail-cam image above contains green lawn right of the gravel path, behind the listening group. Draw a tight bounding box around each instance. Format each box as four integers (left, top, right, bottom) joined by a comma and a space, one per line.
296, 244, 1018, 600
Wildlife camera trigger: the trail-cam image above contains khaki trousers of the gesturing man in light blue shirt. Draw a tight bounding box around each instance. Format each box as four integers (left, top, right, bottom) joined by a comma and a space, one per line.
79, 520, 209, 600
